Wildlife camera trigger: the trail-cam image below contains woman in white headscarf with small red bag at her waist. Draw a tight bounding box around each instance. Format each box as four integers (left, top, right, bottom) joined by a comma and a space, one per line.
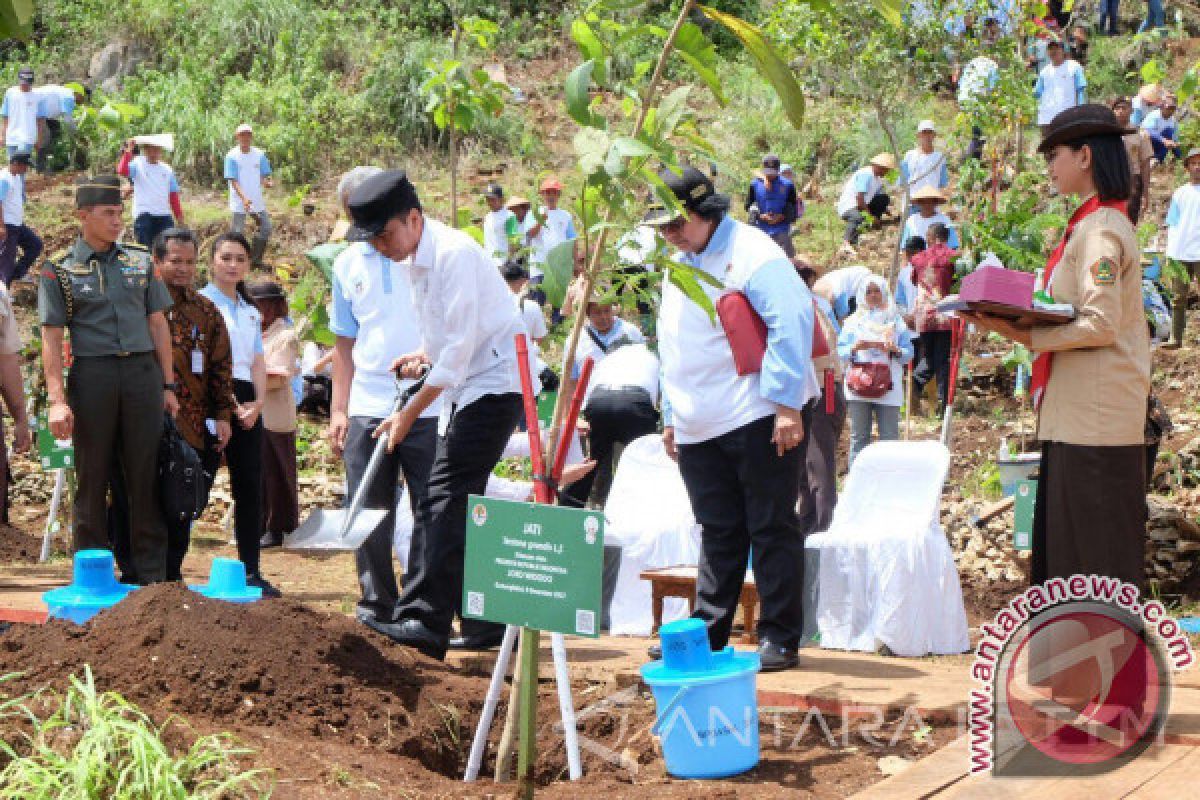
838, 275, 912, 464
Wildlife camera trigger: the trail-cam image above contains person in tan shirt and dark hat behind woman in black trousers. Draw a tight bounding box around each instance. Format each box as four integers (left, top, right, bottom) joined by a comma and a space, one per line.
247, 281, 300, 547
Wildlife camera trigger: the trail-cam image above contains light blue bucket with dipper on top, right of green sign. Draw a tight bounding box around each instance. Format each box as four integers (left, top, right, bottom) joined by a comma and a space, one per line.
642, 619, 760, 778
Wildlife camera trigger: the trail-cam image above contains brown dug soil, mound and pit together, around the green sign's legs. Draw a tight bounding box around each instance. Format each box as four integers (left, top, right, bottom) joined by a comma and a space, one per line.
0, 584, 955, 799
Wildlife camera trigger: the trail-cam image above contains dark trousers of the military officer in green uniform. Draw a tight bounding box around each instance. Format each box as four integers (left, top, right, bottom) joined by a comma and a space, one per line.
67, 353, 167, 583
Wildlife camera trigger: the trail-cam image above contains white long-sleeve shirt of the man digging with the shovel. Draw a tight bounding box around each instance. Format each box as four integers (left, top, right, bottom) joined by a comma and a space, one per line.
407, 217, 524, 419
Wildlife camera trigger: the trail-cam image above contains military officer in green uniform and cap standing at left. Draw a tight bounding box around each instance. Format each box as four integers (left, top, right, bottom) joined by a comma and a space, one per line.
37, 175, 179, 583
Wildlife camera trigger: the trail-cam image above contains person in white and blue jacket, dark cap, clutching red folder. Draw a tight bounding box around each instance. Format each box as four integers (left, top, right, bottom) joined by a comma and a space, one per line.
647, 167, 821, 670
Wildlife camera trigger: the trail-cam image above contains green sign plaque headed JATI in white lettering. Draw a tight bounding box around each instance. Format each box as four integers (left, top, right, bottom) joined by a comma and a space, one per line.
462, 494, 604, 637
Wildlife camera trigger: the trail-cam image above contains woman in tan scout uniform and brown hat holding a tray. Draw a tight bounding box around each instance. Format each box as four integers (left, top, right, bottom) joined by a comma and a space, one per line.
965, 104, 1150, 585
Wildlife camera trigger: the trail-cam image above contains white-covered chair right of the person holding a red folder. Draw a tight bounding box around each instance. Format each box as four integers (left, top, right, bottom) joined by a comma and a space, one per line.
805, 441, 970, 656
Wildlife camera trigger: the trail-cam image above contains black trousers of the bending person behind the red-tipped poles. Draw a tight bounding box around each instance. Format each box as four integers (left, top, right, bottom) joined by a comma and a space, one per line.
560, 386, 659, 509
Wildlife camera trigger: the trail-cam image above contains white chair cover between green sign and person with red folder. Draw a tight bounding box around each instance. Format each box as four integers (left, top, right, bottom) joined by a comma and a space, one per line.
605, 434, 700, 636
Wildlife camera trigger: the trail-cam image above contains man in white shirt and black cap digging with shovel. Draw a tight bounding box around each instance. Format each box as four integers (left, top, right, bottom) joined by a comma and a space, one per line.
347, 169, 524, 658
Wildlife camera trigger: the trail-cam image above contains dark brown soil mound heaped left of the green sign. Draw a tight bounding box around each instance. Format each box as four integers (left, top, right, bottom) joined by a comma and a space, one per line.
0, 584, 477, 775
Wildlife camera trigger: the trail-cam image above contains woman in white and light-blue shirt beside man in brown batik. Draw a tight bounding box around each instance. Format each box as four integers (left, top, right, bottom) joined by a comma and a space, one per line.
200, 233, 280, 597
